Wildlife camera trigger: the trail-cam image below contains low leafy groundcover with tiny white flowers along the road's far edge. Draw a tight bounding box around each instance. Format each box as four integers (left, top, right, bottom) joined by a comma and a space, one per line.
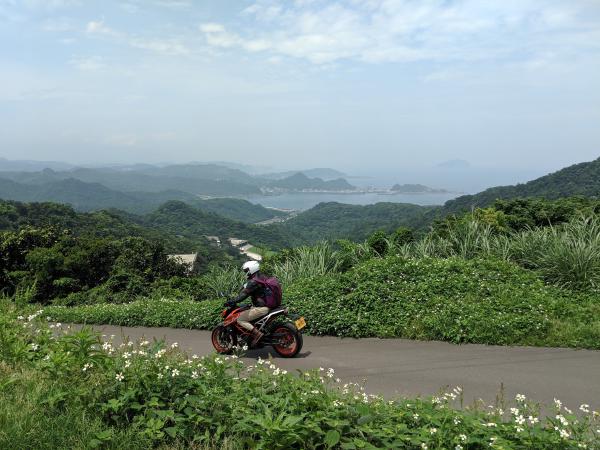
45, 256, 600, 348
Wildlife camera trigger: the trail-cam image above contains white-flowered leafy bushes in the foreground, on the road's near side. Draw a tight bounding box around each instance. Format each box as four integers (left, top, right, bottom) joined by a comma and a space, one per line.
0, 300, 600, 450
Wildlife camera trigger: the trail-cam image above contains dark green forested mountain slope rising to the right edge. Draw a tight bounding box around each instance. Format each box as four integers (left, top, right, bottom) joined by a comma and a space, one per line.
444, 158, 600, 213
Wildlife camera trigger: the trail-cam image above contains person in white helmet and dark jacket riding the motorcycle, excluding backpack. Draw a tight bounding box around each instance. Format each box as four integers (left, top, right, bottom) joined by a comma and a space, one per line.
227, 261, 269, 345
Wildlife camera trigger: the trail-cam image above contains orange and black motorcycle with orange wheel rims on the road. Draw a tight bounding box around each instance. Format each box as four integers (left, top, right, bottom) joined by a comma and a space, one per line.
211, 303, 306, 358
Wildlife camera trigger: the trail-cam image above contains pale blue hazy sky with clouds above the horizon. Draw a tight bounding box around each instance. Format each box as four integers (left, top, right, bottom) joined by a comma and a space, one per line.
0, 0, 600, 171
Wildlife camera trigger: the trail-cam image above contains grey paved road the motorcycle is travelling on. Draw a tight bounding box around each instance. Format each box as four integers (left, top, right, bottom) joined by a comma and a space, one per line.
77, 325, 600, 409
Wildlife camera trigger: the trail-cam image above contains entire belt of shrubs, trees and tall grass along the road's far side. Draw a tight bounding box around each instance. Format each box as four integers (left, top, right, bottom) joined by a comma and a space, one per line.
0, 198, 600, 348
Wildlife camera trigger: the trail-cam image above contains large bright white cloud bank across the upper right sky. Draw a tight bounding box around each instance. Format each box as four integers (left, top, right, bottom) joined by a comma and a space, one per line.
199, 0, 600, 64
